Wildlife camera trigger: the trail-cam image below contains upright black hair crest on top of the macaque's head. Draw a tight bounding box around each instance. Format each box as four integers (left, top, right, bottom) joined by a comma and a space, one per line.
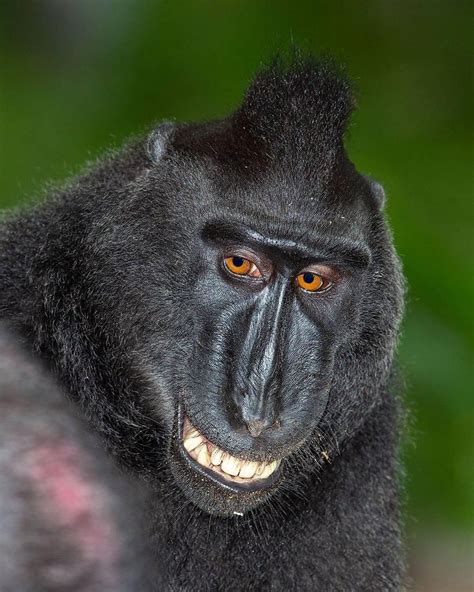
234, 49, 355, 169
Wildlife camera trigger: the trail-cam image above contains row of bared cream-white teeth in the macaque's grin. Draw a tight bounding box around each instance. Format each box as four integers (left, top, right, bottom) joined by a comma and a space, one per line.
183, 418, 281, 481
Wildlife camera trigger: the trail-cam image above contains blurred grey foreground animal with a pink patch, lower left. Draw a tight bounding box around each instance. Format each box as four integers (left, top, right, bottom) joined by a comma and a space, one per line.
0, 329, 156, 592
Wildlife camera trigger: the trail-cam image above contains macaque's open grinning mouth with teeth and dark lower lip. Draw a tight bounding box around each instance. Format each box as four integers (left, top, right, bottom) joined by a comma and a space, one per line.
181, 416, 281, 491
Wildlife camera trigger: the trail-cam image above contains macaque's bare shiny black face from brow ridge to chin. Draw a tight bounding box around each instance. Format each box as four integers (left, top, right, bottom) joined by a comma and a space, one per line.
168, 218, 368, 512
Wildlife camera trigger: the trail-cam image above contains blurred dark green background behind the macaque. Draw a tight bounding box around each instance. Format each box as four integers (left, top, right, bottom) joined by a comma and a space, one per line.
0, 0, 474, 592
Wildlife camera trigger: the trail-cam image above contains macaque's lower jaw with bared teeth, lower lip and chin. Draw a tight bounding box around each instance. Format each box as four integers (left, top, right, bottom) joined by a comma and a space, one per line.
169, 405, 285, 517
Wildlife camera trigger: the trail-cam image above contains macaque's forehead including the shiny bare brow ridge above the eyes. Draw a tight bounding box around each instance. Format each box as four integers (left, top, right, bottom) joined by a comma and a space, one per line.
196, 168, 370, 267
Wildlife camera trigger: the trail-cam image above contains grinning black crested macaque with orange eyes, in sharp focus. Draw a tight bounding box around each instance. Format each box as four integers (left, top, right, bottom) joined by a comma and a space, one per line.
0, 57, 404, 592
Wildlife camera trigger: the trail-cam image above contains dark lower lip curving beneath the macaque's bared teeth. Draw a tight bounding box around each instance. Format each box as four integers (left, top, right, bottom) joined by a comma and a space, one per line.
178, 404, 283, 494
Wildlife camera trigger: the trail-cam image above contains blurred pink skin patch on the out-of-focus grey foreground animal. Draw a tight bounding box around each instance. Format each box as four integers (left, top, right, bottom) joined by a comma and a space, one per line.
22, 440, 120, 589
